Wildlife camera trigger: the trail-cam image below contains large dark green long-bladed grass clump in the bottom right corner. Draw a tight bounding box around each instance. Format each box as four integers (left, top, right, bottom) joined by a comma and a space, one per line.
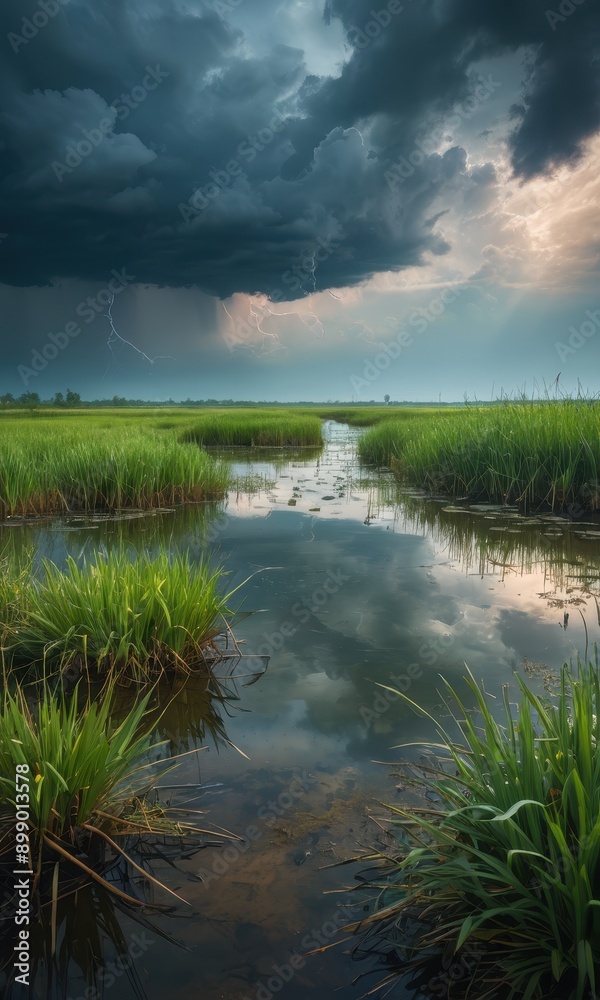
352, 662, 600, 1000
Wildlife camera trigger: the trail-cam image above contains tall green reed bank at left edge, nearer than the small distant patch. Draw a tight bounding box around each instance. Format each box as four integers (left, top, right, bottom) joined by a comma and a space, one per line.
0, 419, 229, 517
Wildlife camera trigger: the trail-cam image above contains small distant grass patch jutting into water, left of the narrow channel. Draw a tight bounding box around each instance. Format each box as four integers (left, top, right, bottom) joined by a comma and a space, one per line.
182, 410, 323, 448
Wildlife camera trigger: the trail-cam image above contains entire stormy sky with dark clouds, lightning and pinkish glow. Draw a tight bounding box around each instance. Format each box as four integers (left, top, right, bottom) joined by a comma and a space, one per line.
0, 0, 600, 401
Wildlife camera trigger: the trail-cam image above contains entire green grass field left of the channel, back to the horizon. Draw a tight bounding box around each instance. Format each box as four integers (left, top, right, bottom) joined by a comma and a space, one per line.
0, 409, 322, 517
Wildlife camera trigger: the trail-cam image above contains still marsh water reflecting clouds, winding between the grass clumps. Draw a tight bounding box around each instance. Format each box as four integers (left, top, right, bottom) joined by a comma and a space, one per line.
0, 424, 600, 1000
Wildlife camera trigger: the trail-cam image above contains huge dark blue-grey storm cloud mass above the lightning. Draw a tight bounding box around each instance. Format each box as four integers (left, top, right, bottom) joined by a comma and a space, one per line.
0, 0, 599, 299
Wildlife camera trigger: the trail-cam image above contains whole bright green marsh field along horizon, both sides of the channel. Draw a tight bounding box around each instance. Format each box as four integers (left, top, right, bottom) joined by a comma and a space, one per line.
0, 400, 600, 517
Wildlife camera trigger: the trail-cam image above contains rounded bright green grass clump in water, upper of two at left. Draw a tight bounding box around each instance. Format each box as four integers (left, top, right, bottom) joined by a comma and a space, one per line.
6, 551, 235, 680
